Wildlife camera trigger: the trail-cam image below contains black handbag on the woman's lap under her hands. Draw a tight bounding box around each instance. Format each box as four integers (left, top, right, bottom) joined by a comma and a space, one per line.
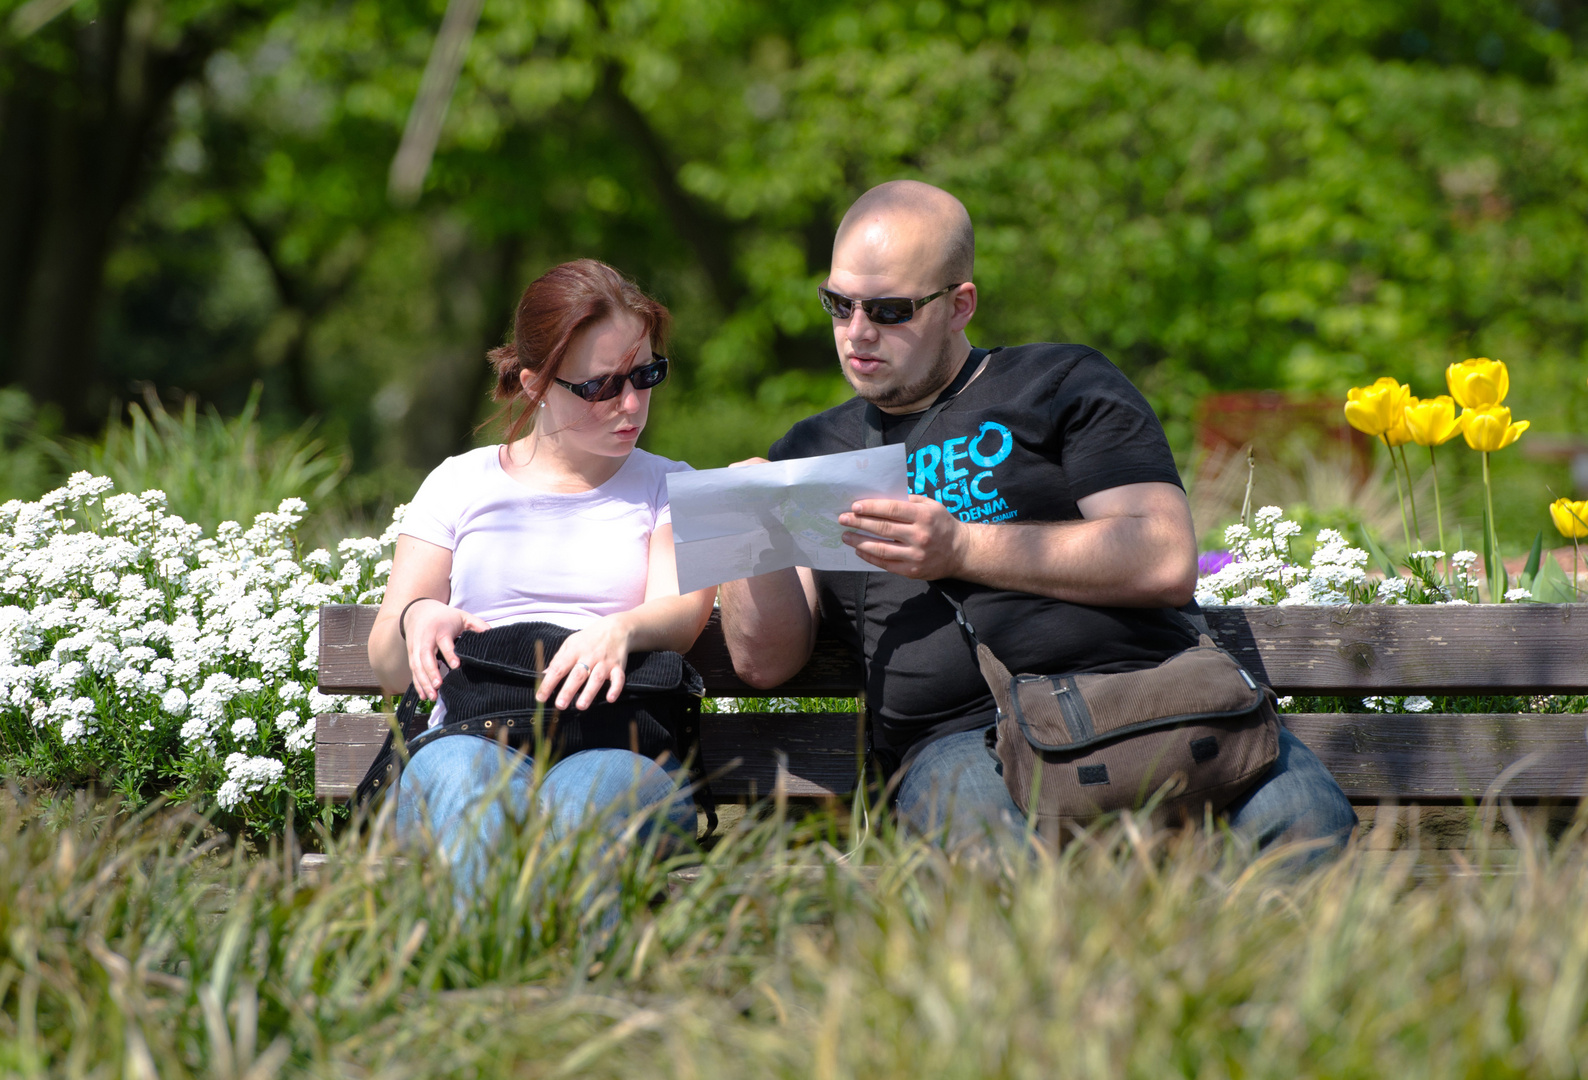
354, 623, 716, 827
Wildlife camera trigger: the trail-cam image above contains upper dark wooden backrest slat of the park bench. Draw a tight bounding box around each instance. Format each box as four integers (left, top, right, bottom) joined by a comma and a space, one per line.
319, 604, 1588, 697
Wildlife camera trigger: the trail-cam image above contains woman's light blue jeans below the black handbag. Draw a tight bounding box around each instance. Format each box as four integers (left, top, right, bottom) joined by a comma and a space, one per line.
394, 735, 696, 902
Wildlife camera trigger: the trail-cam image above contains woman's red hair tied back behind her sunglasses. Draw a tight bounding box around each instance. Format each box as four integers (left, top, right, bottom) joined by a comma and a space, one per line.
489, 259, 673, 443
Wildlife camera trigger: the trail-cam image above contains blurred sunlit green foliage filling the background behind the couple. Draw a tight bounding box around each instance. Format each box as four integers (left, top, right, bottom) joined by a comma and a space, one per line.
0, 0, 1588, 543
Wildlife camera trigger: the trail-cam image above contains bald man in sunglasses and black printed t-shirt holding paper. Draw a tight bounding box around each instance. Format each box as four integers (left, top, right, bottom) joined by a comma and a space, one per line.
721, 181, 1356, 847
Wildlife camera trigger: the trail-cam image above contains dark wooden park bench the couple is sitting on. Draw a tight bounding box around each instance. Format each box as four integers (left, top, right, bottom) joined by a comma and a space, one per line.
314, 604, 1588, 805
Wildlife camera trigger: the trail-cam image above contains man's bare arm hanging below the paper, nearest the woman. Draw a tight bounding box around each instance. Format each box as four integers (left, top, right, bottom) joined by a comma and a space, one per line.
718, 570, 816, 689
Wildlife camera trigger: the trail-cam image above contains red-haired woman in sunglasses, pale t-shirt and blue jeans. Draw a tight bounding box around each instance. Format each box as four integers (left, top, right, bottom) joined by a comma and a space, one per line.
370, 259, 715, 891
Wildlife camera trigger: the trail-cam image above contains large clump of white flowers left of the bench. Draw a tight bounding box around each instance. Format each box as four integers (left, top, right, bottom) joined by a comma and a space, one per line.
0, 472, 397, 834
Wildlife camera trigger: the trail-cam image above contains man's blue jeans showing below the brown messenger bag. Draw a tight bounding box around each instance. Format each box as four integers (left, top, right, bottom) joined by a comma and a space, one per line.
899, 727, 1356, 864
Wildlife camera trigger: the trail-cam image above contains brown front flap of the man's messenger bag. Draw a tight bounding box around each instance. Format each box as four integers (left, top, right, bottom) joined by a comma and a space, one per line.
999, 635, 1269, 753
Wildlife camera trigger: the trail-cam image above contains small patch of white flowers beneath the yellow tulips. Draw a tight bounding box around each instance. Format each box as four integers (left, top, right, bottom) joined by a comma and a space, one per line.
1196, 507, 1480, 607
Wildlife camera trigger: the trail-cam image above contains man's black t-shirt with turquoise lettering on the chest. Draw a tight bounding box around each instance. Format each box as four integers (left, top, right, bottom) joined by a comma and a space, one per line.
769, 345, 1196, 762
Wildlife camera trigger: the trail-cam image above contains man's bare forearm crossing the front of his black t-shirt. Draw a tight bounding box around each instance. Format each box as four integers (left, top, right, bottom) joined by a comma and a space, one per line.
958, 516, 1196, 607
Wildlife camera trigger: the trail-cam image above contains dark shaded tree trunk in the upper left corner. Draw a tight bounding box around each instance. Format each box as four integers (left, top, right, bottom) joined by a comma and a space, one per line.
0, 0, 260, 432
